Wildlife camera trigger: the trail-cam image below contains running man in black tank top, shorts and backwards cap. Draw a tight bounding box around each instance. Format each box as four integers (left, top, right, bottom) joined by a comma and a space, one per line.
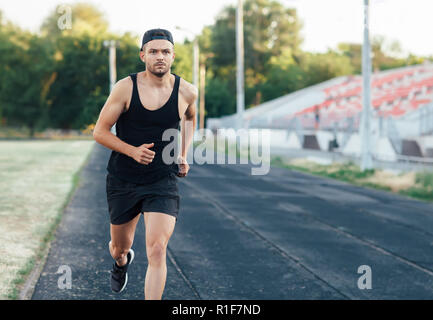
93, 29, 198, 300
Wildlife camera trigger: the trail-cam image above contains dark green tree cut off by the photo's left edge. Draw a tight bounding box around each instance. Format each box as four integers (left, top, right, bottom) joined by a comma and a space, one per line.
0, 16, 52, 136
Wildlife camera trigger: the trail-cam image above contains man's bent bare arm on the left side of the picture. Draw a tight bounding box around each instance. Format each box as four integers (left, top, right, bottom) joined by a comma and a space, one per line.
93, 78, 135, 157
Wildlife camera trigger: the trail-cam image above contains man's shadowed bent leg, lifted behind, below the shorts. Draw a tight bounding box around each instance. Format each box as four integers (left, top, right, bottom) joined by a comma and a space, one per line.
108, 214, 140, 267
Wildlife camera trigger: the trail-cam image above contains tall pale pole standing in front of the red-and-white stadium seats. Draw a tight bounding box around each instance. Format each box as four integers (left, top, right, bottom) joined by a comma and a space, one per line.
360, 0, 373, 171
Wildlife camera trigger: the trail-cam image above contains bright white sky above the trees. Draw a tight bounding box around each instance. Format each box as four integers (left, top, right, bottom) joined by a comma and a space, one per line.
0, 0, 433, 55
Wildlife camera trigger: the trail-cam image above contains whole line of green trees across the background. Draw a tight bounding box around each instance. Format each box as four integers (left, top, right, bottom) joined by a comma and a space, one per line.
0, 0, 426, 134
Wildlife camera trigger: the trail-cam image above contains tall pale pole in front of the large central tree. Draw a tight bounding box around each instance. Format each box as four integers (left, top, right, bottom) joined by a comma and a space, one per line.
236, 0, 245, 129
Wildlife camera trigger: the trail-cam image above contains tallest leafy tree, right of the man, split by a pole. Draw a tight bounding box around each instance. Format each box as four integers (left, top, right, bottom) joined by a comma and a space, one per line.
205, 0, 302, 106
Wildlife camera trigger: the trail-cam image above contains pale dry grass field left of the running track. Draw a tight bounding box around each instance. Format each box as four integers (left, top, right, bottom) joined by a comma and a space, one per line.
0, 140, 94, 299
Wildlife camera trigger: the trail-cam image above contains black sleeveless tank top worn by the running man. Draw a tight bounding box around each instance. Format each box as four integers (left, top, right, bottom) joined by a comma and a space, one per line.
107, 73, 181, 184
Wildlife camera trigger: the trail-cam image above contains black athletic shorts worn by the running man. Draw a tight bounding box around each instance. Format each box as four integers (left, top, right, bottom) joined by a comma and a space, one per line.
106, 173, 179, 225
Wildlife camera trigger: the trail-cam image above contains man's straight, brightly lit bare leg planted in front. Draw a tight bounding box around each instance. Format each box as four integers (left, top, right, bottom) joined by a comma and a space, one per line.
143, 212, 176, 300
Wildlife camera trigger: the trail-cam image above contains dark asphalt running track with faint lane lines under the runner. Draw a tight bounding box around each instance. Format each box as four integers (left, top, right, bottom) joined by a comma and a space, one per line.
32, 143, 433, 300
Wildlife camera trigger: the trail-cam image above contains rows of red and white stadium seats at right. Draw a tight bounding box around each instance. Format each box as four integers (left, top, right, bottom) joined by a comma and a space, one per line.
294, 65, 433, 129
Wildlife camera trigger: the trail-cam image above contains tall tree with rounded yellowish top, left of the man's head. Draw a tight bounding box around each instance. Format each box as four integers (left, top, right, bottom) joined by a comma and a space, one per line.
41, 3, 116, 129
